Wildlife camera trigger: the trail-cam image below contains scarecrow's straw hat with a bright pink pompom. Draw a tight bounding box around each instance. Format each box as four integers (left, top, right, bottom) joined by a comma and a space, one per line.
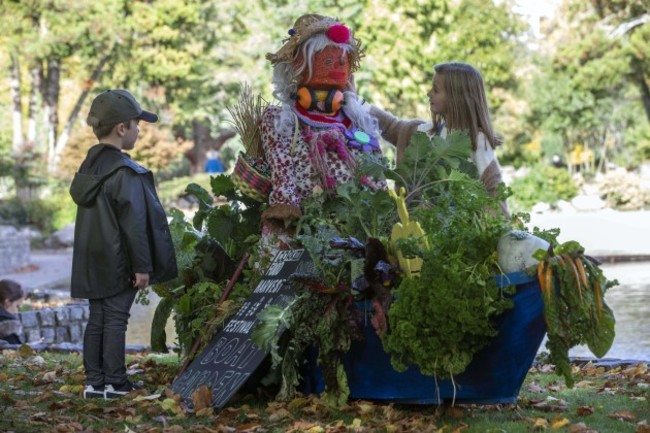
266, 14, 363, 71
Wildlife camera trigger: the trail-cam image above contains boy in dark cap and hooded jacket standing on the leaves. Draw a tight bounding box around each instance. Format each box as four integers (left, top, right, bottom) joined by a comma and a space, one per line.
70, 90, 177, 398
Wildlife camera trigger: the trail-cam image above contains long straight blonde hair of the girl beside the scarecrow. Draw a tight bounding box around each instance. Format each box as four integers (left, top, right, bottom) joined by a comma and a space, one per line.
433, 62, 501, 150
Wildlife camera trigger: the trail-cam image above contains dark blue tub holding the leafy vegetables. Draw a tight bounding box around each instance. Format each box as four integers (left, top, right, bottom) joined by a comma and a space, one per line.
305, 272, 546, 404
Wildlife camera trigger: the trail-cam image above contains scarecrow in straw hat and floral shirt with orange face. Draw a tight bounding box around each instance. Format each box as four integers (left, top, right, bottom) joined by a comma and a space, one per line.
240, 14, 385, 248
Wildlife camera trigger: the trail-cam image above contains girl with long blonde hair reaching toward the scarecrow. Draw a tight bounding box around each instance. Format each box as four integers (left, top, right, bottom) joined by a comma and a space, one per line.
370, 62, 510, 217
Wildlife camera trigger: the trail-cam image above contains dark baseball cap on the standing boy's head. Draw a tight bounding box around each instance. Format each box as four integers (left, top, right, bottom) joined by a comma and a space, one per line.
86, 89, 158, 127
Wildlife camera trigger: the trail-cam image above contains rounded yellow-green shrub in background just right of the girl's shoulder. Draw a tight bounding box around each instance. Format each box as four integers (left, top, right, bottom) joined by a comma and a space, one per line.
510, 164, 578, 211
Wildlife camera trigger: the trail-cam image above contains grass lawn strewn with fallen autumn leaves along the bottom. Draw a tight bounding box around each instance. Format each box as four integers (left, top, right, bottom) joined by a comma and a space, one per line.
0, 347, 650, 433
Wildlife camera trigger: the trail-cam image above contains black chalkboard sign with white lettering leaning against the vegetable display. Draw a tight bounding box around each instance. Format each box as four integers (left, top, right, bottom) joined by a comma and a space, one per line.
171, 249, 315, 408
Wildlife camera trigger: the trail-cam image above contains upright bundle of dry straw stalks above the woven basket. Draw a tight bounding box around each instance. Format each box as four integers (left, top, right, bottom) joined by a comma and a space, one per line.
227, 83, 268, 157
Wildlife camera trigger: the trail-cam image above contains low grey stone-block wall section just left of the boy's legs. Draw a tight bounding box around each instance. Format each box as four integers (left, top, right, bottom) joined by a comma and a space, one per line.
18, 303, 88, 344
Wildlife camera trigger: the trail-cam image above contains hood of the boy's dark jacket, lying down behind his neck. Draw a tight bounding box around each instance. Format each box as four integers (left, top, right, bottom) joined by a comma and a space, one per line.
70, 144, 146, 207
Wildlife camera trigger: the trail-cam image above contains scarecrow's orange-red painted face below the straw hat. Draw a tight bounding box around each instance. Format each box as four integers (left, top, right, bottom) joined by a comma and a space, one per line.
301, 46, 350, 90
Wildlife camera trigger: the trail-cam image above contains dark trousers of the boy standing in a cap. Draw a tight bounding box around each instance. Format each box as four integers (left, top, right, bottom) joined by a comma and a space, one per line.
83, 288, 138, 387
